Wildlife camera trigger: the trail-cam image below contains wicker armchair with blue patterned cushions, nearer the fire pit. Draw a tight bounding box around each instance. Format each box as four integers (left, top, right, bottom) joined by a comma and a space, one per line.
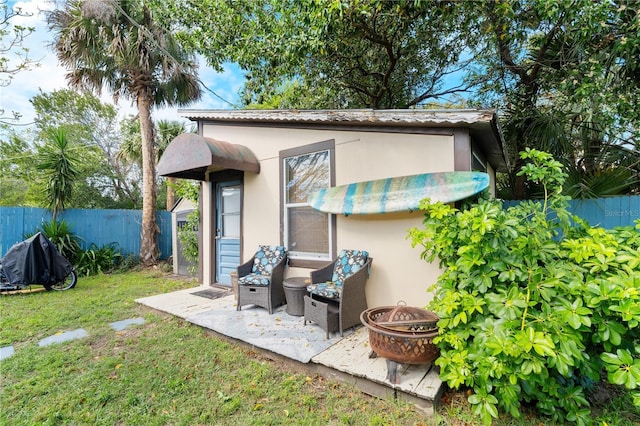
304, 250, 373, 339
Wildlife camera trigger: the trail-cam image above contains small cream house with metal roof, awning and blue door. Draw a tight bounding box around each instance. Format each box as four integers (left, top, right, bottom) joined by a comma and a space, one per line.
158, 110, 508, 307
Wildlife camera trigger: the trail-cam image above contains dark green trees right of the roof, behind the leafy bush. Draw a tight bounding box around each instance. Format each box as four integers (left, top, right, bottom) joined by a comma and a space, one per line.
464, 0, 640, 198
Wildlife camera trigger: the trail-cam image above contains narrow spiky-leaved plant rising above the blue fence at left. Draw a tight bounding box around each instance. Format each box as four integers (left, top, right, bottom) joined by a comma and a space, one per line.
36, 127, 78, 222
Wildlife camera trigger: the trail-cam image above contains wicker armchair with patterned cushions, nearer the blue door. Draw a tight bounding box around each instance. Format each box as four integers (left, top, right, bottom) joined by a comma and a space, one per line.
236, 246, 287, 314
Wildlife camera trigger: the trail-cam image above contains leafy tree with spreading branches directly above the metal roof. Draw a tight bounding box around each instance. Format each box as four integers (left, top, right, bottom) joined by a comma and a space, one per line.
156, 0, 478, 108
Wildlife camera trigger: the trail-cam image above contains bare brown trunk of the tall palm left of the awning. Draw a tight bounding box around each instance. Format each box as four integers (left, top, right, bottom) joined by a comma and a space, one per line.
137, 92, 159, 266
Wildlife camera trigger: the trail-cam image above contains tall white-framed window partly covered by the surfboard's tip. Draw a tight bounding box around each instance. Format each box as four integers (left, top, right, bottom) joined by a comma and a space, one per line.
280, 141, 335, 263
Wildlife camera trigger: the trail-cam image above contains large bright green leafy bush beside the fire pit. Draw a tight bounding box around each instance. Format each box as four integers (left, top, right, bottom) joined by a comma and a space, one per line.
410, 150, 640, 424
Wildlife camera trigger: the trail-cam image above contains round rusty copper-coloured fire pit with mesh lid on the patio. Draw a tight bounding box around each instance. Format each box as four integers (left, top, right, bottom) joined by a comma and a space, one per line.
360, 305, 440, 384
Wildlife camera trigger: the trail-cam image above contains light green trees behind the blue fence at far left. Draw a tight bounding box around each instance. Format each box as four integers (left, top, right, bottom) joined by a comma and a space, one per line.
0, 89, 142, 208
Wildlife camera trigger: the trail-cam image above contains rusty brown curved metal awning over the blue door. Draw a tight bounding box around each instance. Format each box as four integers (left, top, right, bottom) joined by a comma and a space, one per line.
158, 133, 260, 180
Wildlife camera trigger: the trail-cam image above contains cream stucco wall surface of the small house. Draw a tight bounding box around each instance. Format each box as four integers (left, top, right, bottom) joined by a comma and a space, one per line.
202, 123, 455, 306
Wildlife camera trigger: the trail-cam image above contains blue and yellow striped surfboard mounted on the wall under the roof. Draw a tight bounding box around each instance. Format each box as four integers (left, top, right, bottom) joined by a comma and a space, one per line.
308, 172, 489, 215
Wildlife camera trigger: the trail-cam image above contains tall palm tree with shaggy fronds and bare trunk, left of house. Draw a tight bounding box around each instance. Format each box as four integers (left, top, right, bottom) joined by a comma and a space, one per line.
47, 0, 201, 265
